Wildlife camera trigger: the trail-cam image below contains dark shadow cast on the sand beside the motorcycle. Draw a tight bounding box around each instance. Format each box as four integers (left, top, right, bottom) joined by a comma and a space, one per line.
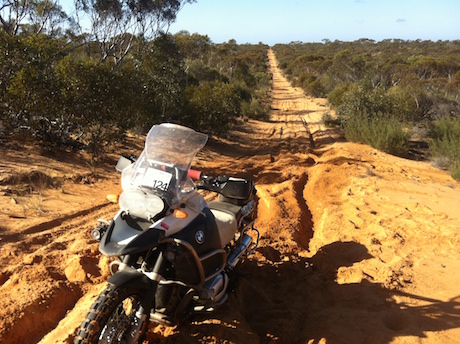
149, 242, 460, 344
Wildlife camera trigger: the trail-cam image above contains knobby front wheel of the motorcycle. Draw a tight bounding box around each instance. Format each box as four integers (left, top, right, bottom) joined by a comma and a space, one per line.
74, 285, 150, 344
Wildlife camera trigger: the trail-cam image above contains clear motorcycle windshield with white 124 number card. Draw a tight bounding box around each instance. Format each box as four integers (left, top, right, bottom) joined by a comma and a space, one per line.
121, 123, 208, 205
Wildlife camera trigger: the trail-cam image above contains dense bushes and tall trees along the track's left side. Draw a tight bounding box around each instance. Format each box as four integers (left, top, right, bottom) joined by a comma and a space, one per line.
0, 0, 271, 155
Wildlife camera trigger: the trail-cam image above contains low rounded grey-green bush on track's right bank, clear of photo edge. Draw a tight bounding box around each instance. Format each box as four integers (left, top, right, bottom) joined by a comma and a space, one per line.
344, 114, 410, 155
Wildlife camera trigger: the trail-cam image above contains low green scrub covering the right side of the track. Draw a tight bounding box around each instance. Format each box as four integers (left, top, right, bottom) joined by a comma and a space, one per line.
274, 39, 460, 179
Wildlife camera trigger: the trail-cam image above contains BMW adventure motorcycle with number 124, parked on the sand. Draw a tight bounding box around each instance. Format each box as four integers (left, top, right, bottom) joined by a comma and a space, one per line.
74, 123, 259, 343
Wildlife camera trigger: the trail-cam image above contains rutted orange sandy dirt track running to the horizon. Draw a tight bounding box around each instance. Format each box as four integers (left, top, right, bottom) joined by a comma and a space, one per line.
0, 52, 460, 344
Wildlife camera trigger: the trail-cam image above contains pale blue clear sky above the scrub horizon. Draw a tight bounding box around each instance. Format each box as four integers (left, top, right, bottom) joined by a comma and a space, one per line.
169, 0, 460, 45
